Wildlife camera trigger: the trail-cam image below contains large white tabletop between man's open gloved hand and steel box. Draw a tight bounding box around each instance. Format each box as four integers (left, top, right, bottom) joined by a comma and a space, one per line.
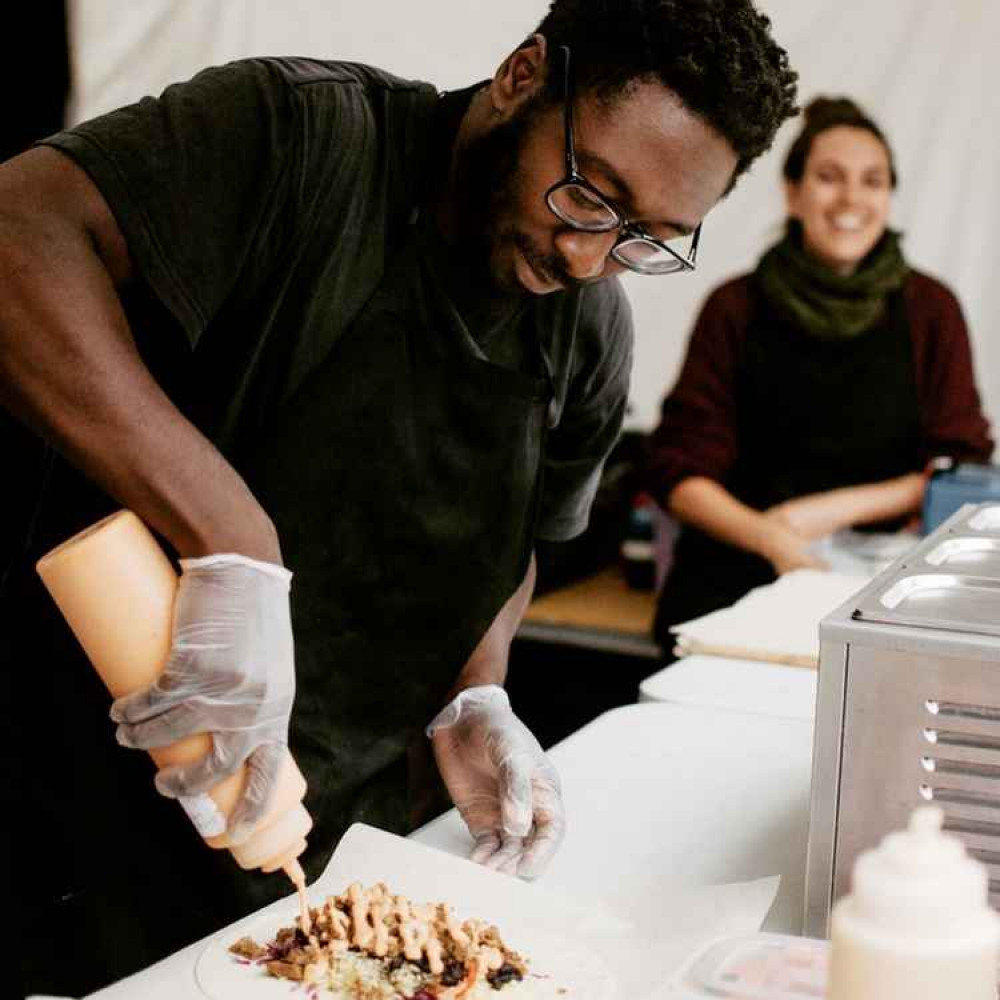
413, 703, 812, 934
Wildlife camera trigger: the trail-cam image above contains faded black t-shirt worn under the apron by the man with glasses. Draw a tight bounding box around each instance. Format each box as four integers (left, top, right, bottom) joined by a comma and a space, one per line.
39, 59, 632, 544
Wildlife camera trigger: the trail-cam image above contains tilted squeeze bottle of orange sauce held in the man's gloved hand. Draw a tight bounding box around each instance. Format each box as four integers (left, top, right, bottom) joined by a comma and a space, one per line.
36, 510, 312, 913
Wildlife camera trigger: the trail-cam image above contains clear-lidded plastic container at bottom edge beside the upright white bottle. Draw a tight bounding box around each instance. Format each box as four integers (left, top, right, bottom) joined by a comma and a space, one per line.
669, 934, 829, 1000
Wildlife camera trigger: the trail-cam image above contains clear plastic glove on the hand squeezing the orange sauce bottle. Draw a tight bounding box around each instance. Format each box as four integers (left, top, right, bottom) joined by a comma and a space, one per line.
111, 555, 295, 844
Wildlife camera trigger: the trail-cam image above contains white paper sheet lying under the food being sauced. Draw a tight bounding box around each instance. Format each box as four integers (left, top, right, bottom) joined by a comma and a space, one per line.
93, 824, 779, 1000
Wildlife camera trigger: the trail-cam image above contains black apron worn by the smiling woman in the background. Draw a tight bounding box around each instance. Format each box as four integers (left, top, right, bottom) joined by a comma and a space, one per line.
654, 287, 921, 653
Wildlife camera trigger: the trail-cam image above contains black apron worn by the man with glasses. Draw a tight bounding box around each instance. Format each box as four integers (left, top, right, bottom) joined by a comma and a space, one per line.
244, 215, 552, 875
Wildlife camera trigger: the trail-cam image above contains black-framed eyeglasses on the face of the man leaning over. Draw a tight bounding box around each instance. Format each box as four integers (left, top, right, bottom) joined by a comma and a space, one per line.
545, 45, 701, 274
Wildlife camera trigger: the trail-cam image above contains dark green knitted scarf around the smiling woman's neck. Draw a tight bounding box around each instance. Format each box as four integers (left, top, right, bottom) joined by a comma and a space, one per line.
757, 219, 909, 340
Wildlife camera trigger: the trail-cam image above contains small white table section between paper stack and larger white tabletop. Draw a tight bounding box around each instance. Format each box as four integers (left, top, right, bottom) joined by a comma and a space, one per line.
639, 656, 819, 719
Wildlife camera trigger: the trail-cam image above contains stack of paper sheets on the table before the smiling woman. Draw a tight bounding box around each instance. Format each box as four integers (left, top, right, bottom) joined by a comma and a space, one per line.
671, 569, 868, 666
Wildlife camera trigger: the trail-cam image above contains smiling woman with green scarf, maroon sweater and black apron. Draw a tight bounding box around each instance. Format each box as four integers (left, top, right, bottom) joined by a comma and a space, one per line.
649, 98, 993, 648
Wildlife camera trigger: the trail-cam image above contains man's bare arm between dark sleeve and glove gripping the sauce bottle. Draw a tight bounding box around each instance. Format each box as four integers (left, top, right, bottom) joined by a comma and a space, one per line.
0, 147, 281, 562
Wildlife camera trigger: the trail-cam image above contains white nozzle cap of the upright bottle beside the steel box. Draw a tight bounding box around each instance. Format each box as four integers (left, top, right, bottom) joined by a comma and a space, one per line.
853, 806, 993, 938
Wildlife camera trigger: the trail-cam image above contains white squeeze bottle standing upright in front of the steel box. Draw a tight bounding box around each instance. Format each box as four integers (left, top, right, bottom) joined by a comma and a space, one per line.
829, 806, 1000, 1000
